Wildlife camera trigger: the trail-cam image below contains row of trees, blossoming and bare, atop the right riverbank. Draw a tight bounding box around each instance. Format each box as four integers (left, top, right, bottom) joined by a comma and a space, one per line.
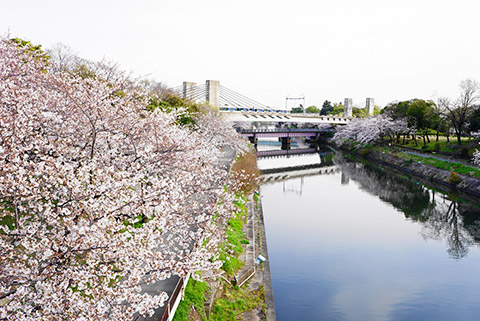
334, 79, 480, 163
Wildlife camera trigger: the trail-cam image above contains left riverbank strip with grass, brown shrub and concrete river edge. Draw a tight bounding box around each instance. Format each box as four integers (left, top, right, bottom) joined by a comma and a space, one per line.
170, 147, 276, 321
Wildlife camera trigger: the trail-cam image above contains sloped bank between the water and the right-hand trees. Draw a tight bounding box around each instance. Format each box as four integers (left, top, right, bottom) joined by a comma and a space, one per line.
354, 149, 480, 198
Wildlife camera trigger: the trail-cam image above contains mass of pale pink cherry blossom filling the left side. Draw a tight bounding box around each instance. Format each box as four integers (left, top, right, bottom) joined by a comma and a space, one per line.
0, 39, 241, 320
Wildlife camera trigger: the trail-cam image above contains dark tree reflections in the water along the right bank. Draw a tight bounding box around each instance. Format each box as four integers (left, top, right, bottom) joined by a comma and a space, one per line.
334, 154, 480, 259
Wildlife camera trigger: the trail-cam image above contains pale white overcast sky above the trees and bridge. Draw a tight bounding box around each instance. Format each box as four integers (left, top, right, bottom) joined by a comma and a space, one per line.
0, 0, 480, 107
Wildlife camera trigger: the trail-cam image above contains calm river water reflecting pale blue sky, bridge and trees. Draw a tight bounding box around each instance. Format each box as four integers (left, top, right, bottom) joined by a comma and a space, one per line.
259, 150, 480, 321
